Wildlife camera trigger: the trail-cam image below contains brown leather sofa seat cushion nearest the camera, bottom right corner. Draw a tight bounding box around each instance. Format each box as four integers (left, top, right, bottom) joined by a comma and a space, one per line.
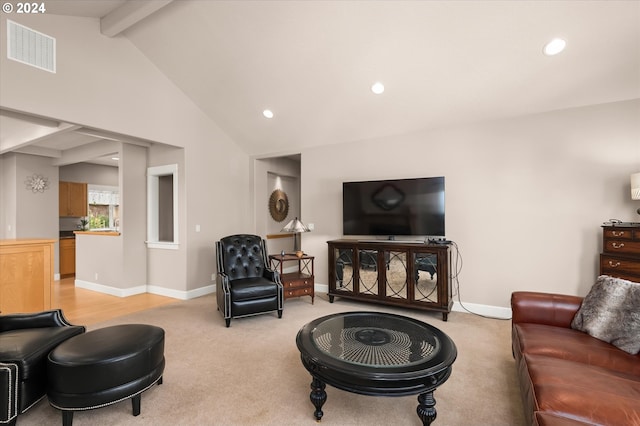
525, 354, 640, 425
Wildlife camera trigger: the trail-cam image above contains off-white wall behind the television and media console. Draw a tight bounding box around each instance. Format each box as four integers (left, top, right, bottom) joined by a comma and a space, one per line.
301, 100, 640, 307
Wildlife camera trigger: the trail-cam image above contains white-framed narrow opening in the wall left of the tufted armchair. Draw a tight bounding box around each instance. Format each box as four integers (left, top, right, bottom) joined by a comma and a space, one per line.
147, 164, 178, 250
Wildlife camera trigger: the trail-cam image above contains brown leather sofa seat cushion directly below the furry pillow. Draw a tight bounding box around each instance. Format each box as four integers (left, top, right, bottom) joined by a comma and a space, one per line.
513, 324, 640, 377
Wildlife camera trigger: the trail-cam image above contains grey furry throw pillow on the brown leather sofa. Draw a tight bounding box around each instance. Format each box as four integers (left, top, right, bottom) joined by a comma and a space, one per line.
571, 275, 640, 355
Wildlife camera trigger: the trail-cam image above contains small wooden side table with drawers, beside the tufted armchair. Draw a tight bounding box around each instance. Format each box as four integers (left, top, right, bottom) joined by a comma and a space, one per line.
269, 253, 315, 305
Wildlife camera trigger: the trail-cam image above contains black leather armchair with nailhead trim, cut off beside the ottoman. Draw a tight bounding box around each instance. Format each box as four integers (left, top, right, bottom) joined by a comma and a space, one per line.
0, 309, 85, 425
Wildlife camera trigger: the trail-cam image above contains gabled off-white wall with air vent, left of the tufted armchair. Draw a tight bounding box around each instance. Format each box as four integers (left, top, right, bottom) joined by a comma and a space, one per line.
0, 15, 253, 297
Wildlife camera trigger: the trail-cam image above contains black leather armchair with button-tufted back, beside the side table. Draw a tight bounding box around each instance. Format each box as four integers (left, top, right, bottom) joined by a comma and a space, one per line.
216, 234, 284, 327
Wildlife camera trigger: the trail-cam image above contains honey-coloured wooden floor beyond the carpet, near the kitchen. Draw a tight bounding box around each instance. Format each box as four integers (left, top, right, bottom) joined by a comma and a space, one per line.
51, 278, 178, 325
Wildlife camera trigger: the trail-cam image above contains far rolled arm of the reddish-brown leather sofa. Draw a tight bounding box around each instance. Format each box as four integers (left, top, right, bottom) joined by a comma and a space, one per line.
511, 291, 582, 328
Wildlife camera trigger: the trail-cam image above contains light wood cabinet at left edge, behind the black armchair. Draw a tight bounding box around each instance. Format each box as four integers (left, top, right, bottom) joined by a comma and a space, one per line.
0, 239, 55, 314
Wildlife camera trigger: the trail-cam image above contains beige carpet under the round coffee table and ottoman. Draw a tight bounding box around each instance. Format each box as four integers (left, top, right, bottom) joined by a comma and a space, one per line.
18, 294, 524, 426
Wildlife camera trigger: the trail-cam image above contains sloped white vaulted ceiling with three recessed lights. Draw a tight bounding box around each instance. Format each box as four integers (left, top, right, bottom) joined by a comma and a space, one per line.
0, 0, 640, 161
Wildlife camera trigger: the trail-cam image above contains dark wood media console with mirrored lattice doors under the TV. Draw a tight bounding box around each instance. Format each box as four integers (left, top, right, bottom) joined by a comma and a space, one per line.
327, 240, 453, 321
